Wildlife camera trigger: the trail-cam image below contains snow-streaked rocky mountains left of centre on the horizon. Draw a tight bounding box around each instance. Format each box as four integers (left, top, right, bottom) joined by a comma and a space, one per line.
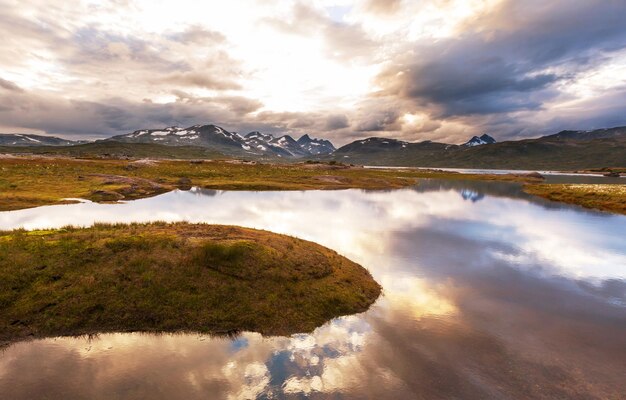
107, 125, 335, 157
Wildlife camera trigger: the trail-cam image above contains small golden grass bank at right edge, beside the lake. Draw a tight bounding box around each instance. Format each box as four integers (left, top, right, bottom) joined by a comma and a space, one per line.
524, 184, 626, 215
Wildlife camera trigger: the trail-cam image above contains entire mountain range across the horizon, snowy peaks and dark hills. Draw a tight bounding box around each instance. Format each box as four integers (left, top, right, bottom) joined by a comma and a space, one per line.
0, 125, 626, 170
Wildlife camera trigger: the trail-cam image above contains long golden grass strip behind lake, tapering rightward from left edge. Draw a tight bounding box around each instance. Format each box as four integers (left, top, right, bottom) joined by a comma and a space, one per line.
0, 157, 527, 211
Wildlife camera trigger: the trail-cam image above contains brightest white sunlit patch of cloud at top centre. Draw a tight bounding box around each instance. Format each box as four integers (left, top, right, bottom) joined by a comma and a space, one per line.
73, 0, 379, 112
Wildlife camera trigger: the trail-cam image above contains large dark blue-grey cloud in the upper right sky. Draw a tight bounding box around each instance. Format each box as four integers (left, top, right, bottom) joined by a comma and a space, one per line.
379, 1, 626, 118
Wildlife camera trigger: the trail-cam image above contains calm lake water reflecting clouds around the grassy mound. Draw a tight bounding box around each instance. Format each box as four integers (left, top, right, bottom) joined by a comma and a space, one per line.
0, 181, 626, 399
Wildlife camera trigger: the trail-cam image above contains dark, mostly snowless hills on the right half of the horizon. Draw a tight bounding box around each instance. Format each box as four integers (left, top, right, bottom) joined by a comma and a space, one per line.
323, 127, 626, 169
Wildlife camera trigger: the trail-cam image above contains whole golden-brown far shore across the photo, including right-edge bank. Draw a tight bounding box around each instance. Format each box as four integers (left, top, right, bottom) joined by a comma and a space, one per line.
0, 156, 626, 214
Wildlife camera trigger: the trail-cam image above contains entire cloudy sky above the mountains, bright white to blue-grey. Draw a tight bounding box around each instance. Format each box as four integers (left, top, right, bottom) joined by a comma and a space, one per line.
0, 0, 626, 144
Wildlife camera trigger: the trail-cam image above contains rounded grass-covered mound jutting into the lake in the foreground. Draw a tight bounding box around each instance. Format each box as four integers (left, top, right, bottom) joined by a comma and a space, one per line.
0, 223, 381, 344
